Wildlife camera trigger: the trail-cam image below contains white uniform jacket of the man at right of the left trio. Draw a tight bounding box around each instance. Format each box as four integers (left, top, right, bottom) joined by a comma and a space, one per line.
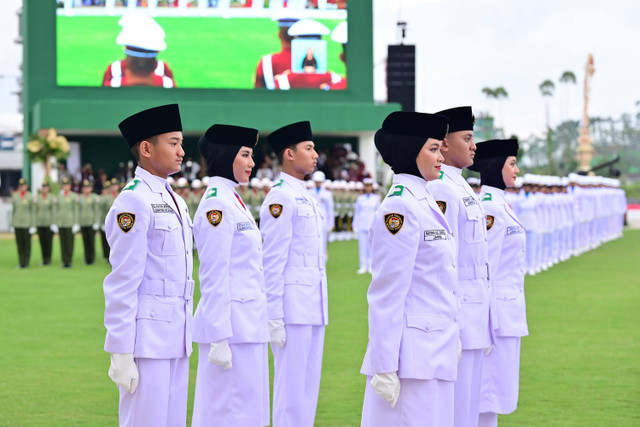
260, 172, 329, 325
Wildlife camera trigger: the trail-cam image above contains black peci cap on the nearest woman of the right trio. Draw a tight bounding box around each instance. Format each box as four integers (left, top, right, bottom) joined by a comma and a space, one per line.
382, 111, 448, 141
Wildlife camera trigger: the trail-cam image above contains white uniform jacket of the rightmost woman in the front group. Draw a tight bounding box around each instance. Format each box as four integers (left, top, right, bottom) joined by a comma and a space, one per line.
481, 185, 529, 337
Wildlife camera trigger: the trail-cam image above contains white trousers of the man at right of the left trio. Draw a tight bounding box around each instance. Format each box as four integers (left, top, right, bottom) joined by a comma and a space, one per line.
271, 325, 325, 427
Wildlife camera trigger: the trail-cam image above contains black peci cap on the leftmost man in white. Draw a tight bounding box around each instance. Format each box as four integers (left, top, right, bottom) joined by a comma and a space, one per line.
118, 104, 182, 148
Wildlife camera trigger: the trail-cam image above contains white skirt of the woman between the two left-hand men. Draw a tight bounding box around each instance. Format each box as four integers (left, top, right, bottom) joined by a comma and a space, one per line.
191, 343, 270, 427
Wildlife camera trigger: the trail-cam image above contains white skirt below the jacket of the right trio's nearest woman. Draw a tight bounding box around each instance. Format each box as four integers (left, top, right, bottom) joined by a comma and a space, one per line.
361, 377, 454, 427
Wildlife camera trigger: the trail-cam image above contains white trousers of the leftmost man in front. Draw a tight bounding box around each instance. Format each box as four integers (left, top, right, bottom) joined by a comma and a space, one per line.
118, 357, 189, 427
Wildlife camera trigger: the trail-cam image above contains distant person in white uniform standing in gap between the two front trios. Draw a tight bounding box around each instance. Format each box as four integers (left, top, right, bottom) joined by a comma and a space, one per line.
352, 178, 380, 274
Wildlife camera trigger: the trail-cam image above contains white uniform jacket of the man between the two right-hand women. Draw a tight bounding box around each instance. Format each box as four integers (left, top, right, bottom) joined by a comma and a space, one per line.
427, 164, 493, 350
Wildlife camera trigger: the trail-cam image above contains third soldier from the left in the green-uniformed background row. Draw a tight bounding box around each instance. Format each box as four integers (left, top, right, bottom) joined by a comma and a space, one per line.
55, 177, 78, 268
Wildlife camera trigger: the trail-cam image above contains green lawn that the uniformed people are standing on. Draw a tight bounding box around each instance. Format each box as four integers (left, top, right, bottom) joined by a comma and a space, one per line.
0, 230, 640, 427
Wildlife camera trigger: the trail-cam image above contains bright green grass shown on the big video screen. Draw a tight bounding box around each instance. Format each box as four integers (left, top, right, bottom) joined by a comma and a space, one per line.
56, 16, 346, 89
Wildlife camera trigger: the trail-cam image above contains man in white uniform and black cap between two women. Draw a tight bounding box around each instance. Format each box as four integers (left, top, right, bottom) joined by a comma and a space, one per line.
427, 107, 493, 427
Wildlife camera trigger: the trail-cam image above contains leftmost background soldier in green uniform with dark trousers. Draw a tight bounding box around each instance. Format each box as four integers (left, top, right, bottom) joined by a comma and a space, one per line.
11, 178, 35, 268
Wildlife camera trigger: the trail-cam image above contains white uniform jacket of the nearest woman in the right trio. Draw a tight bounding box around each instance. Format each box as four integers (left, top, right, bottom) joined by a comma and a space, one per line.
360, 174, 460, 381
